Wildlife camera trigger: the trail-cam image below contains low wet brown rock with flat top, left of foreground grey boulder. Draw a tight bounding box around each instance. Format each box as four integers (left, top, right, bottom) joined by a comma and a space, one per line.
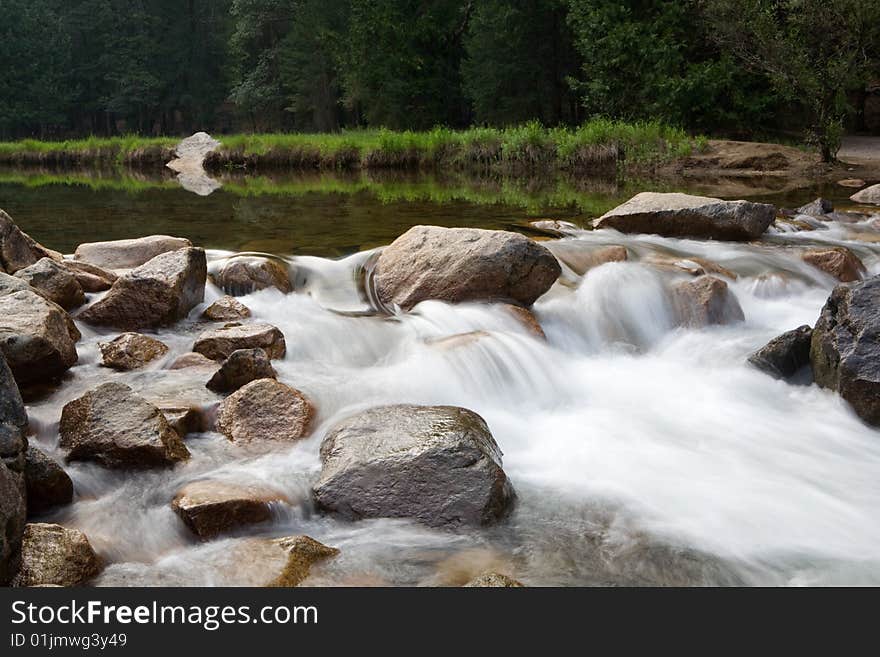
171, 480, 284, 539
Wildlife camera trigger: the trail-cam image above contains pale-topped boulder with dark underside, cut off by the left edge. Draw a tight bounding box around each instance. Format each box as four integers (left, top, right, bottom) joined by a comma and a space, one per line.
0, 290, 79, 384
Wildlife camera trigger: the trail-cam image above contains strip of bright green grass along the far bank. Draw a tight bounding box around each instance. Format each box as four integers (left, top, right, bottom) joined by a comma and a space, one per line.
0, 119, 706, 174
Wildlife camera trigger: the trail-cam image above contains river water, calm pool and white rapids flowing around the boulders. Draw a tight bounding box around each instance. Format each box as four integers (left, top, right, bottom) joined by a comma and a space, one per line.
0, 169, 880, 585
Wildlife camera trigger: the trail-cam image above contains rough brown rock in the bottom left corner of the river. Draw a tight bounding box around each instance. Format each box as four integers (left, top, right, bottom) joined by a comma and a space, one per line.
16, 523, 101, 586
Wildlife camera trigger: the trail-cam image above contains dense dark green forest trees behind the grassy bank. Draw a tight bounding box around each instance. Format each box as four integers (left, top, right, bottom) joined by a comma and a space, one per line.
0, 0, 880, 156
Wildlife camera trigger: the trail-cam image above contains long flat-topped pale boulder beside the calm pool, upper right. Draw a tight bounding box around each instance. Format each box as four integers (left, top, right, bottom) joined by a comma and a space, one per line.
593, 192, 776, 240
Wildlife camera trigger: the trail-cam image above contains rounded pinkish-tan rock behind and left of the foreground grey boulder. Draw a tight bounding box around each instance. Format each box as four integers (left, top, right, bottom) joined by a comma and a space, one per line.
217, 379, 315, 443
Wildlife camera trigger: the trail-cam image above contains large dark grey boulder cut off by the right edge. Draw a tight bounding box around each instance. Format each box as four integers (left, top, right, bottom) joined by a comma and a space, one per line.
810, 276, 880, 425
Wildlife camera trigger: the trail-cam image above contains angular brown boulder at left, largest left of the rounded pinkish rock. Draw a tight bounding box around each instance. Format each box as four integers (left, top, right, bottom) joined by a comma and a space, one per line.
59, 383, 189, 469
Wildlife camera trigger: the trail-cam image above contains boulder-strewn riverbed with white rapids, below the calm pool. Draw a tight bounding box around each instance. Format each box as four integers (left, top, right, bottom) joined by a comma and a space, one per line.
0, 187, 880, 586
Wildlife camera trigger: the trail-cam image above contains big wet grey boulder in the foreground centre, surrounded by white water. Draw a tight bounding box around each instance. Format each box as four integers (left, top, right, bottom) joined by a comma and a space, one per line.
314, 405, 514, 526
